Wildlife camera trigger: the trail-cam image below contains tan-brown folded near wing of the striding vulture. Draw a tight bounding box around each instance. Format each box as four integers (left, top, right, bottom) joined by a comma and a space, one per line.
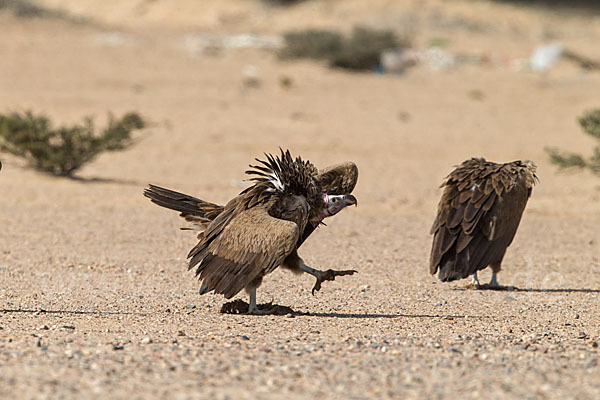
188, 199, 300, 299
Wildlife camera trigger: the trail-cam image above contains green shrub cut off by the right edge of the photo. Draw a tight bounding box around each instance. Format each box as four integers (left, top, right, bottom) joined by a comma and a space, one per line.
546, 108, 600, 175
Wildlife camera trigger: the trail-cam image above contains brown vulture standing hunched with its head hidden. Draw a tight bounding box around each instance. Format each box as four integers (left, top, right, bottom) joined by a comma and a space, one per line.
429, 158, 538, 289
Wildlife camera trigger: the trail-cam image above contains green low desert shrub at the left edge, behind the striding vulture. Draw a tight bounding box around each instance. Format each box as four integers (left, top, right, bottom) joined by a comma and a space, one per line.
0, 111, 147, 176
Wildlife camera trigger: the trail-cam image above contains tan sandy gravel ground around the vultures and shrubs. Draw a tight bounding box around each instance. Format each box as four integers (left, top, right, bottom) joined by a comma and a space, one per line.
0, 0, 600, 399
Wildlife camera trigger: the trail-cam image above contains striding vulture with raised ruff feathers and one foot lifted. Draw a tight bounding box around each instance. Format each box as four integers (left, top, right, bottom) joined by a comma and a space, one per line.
144, 149, 358, 314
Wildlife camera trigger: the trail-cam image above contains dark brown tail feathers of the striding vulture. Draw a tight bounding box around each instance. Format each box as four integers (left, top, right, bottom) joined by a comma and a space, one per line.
144, 185, 223, 224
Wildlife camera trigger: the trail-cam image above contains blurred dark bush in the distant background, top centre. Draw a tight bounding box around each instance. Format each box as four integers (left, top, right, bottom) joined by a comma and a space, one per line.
279, 27, 408, 70
